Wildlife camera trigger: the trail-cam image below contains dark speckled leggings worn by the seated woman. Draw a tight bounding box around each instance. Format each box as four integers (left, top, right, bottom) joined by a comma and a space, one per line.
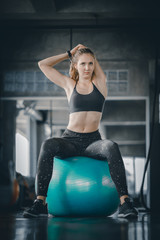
37, 129, 128, 197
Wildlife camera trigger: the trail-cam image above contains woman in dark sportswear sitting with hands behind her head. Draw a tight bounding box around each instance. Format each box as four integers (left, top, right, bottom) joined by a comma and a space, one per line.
24, 44, 137, 217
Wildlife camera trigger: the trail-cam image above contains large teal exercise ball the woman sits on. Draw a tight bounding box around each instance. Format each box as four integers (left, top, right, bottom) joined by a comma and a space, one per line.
46, 156, 119, 216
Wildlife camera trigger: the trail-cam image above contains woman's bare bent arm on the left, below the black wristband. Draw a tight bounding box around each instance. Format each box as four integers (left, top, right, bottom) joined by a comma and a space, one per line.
38, 53, 70, 89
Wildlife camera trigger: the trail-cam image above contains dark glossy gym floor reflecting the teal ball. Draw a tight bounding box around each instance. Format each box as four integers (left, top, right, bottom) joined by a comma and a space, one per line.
0, 211, 160, 240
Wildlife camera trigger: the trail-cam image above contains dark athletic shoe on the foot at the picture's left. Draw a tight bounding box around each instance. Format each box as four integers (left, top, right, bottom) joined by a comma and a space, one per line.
23, 199, 48, 218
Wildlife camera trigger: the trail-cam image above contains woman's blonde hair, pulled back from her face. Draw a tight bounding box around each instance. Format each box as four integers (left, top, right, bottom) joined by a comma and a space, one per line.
69, 48, 95, 82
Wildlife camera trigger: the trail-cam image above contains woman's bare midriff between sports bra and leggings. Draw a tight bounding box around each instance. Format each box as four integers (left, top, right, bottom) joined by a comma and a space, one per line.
67, 111, 102, 133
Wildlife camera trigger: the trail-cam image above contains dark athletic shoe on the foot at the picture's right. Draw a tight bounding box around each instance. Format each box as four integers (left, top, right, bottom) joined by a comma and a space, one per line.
118, 198, 138, 218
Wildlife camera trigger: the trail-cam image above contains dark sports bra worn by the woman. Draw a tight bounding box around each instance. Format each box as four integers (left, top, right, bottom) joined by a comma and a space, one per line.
69, 82, 105, 113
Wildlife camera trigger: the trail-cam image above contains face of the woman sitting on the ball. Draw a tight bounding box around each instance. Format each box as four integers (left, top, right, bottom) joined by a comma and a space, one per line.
75, 53, 95, 79
